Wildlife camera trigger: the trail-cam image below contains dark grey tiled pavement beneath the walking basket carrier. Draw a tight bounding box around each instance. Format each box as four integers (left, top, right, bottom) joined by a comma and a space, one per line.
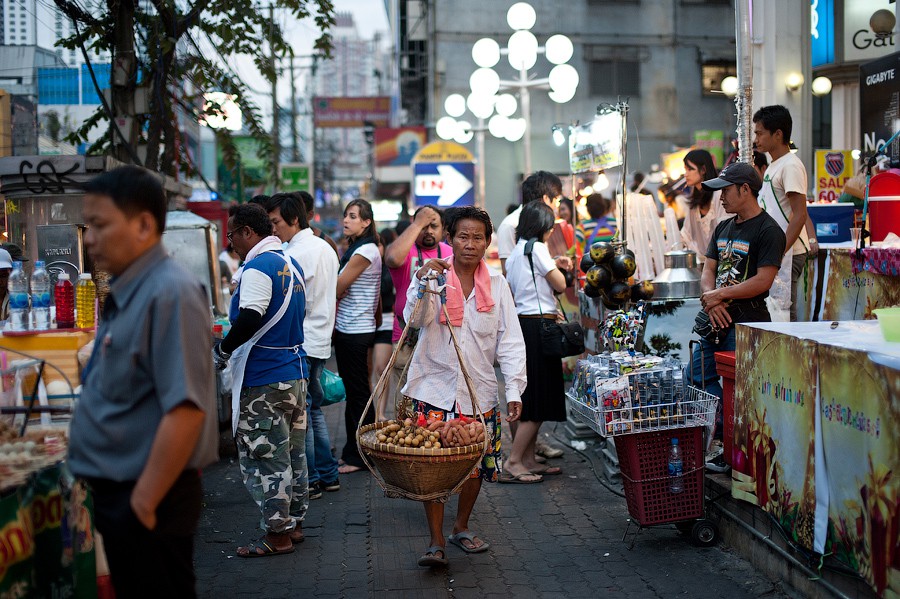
196, 405, 793, 599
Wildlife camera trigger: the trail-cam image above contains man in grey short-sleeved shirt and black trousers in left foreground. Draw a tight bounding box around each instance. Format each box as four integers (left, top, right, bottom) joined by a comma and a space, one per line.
68, 166, 217, 597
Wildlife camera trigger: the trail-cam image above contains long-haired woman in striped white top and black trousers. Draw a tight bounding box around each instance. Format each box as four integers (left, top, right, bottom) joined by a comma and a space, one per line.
333, 199, 381, 474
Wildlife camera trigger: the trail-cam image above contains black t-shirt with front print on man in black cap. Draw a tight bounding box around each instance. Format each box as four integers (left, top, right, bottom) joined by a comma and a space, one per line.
706, 212, 785, 302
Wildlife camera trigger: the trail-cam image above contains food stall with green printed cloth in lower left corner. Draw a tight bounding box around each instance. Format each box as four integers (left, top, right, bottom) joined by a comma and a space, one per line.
0, 344, 97, 597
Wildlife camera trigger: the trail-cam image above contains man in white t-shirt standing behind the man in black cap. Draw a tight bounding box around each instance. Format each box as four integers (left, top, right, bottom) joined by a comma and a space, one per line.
753, 105, 818, 322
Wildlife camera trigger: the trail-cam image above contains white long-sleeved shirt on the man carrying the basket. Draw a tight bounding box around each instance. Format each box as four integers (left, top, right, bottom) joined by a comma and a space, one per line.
403, 272, 527, 414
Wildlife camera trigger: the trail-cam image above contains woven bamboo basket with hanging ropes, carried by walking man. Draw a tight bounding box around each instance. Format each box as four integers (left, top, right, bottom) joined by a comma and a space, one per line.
356, 274, 492, 502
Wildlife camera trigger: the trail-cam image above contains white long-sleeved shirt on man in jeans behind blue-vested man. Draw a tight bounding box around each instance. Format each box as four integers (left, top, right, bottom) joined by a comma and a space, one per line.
285, 228, 338, 360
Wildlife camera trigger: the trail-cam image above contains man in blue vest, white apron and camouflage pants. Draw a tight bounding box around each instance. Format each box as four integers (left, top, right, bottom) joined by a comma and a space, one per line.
213, 204, 309, 557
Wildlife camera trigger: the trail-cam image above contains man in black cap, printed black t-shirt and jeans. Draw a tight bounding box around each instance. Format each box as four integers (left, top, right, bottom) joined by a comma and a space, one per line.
690, 162, 785, 472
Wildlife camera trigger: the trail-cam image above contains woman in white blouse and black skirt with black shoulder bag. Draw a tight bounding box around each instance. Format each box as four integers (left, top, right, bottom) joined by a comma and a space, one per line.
500, 202, 572, 484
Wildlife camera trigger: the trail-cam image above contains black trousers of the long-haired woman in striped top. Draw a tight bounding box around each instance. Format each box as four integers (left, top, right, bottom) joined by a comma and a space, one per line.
333, 331, 375, 468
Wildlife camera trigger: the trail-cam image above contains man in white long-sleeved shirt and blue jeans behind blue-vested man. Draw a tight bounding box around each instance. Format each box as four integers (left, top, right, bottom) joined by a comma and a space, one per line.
266, 193, 341, 499
